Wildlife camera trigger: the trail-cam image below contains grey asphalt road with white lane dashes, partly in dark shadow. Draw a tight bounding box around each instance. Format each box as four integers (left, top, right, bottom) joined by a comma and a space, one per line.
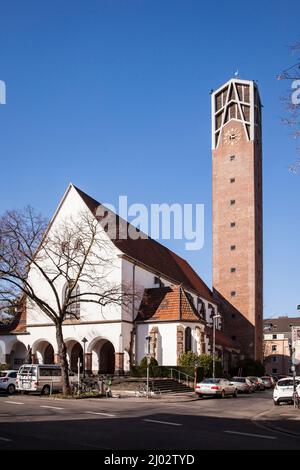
0, 391, 300, 450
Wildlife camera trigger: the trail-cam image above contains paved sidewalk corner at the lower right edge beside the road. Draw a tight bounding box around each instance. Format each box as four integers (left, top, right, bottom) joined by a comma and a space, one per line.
253, 405, 300, 437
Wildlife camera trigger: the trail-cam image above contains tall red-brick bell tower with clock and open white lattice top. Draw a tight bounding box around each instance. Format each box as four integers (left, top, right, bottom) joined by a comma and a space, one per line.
212, 78, 263, 360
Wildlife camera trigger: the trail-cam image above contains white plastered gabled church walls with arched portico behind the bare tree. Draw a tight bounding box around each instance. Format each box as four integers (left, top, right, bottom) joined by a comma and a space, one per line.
0, 184, 223, 373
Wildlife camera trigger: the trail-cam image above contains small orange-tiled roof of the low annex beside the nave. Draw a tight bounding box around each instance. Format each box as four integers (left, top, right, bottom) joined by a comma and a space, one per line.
136, 285, 204, 322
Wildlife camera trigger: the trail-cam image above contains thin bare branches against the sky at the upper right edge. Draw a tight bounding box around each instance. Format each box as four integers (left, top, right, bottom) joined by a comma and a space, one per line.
277, 42, 300, 173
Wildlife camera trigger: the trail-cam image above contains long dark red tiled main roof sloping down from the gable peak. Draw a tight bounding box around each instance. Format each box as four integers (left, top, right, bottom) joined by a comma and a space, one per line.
74, 186, 215, 303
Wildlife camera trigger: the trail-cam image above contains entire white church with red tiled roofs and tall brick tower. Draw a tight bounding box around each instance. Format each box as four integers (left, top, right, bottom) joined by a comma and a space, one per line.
0, 79, 262, 374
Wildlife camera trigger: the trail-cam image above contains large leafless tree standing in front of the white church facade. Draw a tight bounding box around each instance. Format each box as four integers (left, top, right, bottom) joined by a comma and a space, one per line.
0, 207, 132, 394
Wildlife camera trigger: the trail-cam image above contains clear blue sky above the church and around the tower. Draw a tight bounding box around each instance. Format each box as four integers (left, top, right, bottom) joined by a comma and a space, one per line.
0, 0, 300, 317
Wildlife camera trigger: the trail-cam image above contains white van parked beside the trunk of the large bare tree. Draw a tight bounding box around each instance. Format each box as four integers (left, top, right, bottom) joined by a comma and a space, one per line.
16, 364, 76, 395
